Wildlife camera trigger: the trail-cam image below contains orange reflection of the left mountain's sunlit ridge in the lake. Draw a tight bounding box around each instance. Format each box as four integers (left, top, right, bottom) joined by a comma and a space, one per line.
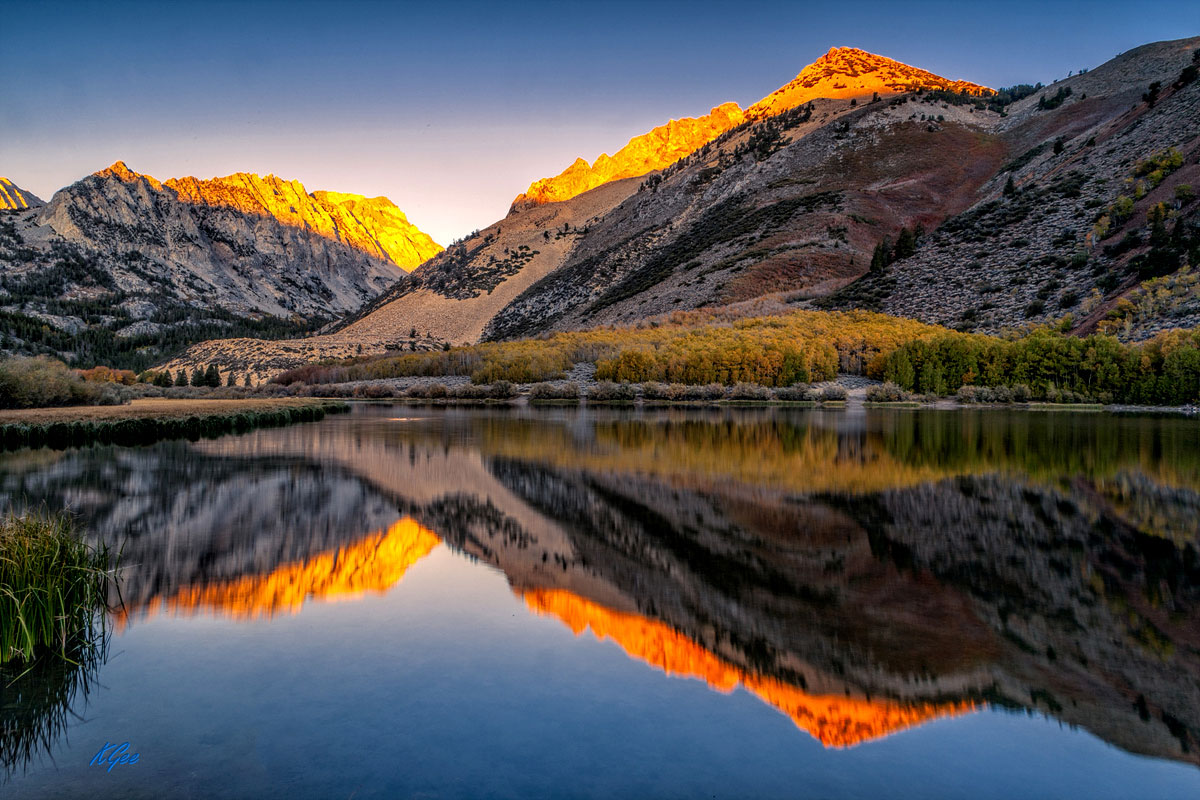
116, 517, 442, 627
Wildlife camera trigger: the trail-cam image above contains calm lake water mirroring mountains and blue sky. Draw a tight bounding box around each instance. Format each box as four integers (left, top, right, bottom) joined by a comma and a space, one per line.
0, 405, 1200, 800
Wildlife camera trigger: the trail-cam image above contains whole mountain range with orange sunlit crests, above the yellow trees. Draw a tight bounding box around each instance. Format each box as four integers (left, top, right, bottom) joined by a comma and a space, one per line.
0, 37, 1200, 379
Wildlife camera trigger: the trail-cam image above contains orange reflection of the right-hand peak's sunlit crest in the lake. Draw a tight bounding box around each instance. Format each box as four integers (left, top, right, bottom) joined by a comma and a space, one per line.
521, 589, 976, 747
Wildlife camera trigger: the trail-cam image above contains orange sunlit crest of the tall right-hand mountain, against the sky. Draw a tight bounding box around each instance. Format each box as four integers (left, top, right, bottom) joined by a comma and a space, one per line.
512, 47, 994, 207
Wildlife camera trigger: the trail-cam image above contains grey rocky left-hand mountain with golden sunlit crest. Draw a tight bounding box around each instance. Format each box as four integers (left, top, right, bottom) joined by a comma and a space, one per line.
0, 162, 440, 367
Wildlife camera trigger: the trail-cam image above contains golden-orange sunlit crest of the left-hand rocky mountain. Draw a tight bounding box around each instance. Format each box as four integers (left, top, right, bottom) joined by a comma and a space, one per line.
96, 161, 442, 271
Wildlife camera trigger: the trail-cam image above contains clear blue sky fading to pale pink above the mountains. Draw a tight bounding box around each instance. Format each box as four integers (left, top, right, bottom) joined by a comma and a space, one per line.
7, 0, 1200, 243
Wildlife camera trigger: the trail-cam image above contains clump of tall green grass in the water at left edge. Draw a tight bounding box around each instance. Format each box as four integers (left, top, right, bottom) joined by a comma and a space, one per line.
0, 512, 113, 664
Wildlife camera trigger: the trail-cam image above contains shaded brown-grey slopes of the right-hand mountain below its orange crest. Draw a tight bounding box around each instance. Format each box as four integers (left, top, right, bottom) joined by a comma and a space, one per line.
159, 37, 1200, 377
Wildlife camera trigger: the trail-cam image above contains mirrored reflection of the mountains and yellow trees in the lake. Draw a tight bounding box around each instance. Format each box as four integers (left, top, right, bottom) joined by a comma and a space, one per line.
0, 408, 1200, 763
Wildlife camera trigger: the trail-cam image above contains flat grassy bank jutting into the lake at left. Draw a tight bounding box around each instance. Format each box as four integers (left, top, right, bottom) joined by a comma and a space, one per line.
0, 397, 349, 450
